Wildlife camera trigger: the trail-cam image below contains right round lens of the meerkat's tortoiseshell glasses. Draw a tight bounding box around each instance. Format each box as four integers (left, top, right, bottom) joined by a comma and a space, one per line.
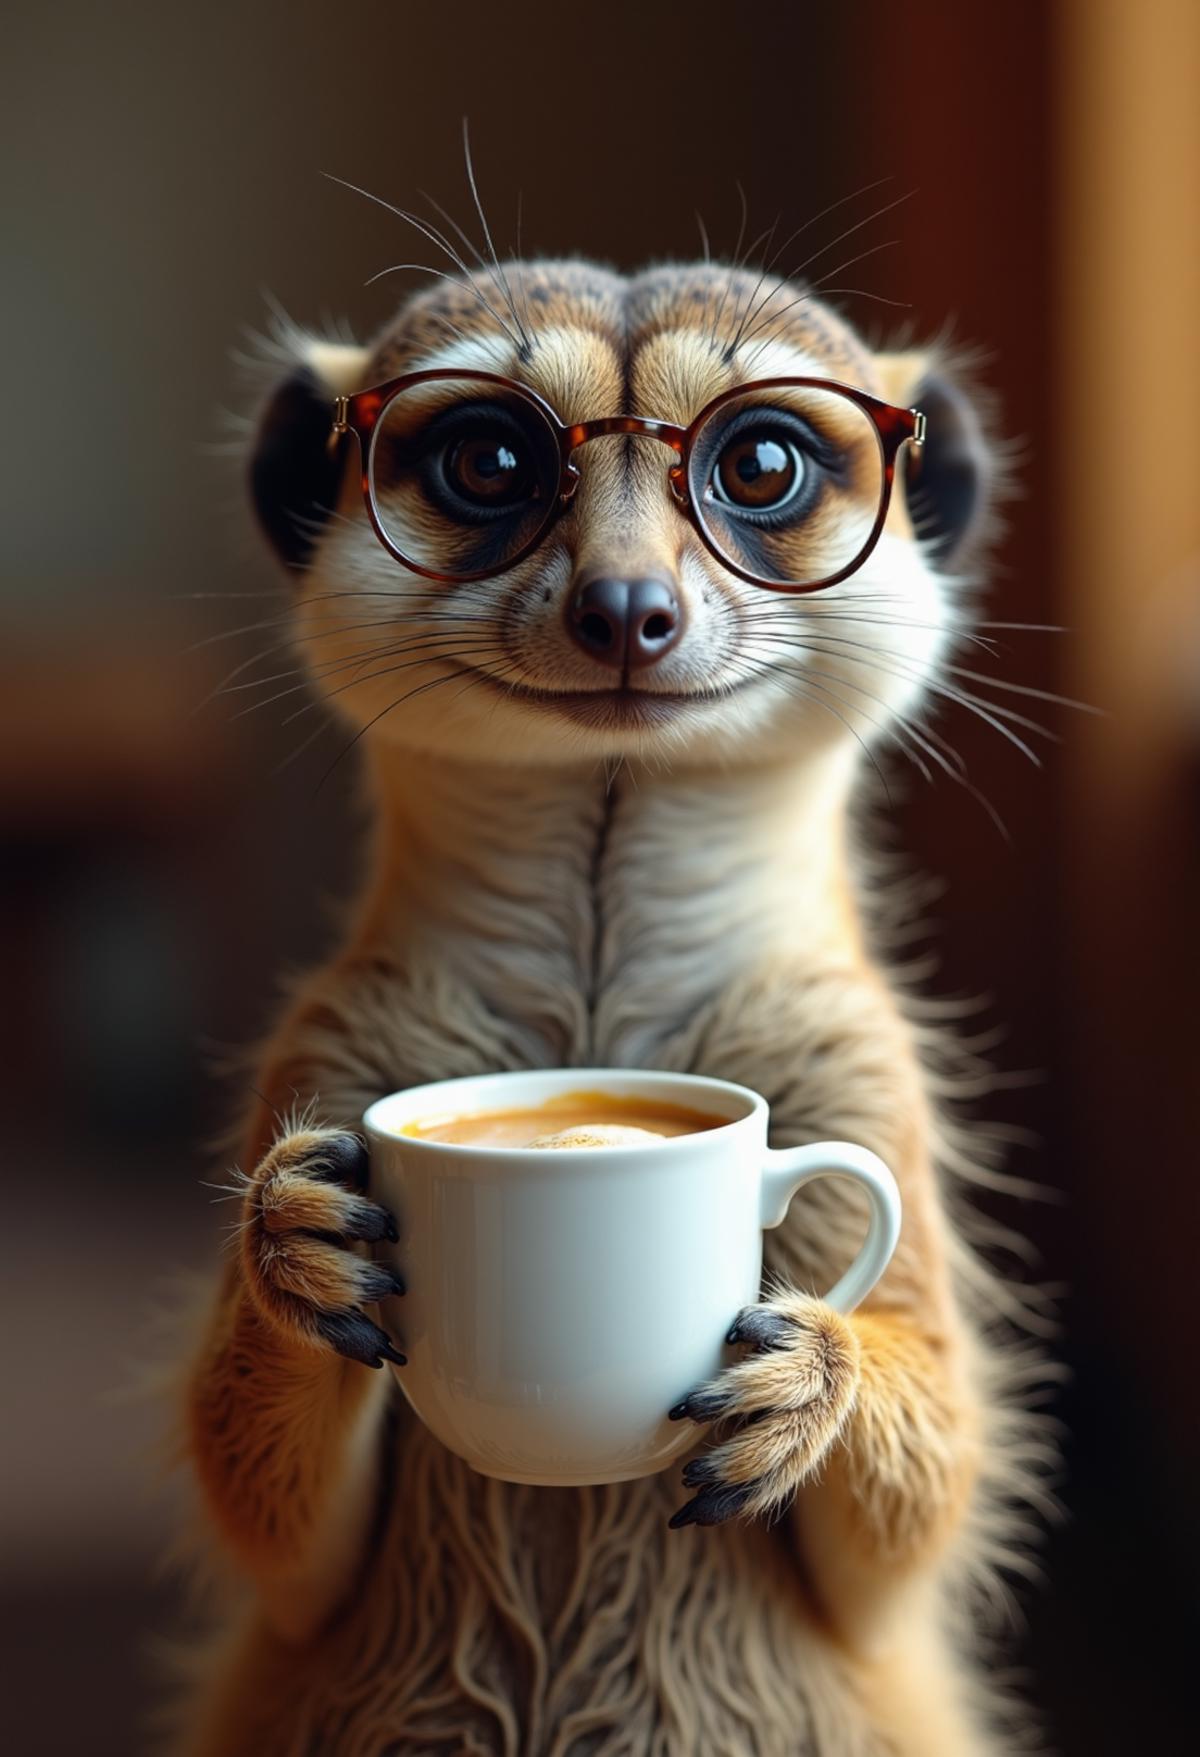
690, 385, 884, 585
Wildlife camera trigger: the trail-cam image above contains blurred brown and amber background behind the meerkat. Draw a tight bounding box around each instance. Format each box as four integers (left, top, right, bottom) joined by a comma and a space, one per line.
0, 0, 1200, 1757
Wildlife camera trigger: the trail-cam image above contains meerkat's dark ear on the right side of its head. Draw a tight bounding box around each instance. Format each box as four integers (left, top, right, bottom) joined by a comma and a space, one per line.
878, 350, 998, 568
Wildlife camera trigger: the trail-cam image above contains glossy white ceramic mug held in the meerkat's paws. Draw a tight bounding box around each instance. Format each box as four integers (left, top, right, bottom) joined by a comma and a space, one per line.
364, 1068, 900, 1486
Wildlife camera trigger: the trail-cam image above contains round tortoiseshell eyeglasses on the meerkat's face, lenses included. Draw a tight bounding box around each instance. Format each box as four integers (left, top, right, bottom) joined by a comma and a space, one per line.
330, 367, 924, 592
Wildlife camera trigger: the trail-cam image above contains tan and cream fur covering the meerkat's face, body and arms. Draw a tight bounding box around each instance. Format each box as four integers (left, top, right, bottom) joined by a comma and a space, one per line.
177, 264, 1054, 1757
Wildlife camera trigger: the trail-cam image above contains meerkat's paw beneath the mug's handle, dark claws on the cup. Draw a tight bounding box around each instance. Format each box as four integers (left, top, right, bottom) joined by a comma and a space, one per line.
669, 1293, 859, 1527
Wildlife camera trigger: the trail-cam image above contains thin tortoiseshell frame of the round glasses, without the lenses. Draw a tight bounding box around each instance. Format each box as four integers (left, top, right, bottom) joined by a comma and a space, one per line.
330, 367, 926, 594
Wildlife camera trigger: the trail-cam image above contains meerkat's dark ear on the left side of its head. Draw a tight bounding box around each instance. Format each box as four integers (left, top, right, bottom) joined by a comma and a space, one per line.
249, 329, 367, 569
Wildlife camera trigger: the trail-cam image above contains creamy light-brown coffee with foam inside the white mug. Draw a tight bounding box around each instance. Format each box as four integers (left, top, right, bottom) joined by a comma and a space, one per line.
401, 1091, 729, 1147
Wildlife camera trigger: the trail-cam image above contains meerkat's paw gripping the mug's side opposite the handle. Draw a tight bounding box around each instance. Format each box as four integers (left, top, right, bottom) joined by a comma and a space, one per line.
242, 1128, 406, 1367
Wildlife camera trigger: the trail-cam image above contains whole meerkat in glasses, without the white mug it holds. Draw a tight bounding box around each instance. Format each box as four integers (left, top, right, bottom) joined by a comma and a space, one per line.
176, 260, 1037, 1757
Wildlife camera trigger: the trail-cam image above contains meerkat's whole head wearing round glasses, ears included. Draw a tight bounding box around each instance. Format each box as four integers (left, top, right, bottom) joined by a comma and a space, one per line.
251, 262, 987, 764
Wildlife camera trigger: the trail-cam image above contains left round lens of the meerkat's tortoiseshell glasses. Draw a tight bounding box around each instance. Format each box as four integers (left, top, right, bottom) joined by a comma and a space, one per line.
369, 376, 559, 580
